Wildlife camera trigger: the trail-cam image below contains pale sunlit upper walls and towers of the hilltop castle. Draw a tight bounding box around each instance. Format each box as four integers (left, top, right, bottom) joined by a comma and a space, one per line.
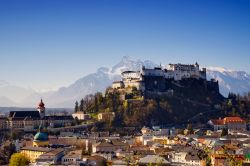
112, 63, 206, 91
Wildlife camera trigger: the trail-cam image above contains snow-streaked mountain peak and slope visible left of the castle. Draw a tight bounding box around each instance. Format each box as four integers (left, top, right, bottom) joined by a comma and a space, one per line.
42, 56, 156, 107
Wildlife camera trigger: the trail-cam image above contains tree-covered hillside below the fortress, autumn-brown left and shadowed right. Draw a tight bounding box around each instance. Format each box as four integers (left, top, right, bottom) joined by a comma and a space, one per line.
75, 79, 250, 130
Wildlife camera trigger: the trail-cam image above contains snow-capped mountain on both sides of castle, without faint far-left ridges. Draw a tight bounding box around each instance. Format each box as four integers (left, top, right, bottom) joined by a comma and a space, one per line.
42, 56, 250, 107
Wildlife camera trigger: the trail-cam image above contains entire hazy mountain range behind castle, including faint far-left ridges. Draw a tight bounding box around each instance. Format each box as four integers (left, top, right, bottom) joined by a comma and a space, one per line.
0, 56, 250, 108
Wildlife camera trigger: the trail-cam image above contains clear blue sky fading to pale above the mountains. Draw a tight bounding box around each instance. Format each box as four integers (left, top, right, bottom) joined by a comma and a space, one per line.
0, 0, 250, 90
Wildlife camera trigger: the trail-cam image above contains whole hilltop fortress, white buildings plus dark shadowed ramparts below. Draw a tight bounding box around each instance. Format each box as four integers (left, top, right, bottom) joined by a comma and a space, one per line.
112, 63, 219, 95
